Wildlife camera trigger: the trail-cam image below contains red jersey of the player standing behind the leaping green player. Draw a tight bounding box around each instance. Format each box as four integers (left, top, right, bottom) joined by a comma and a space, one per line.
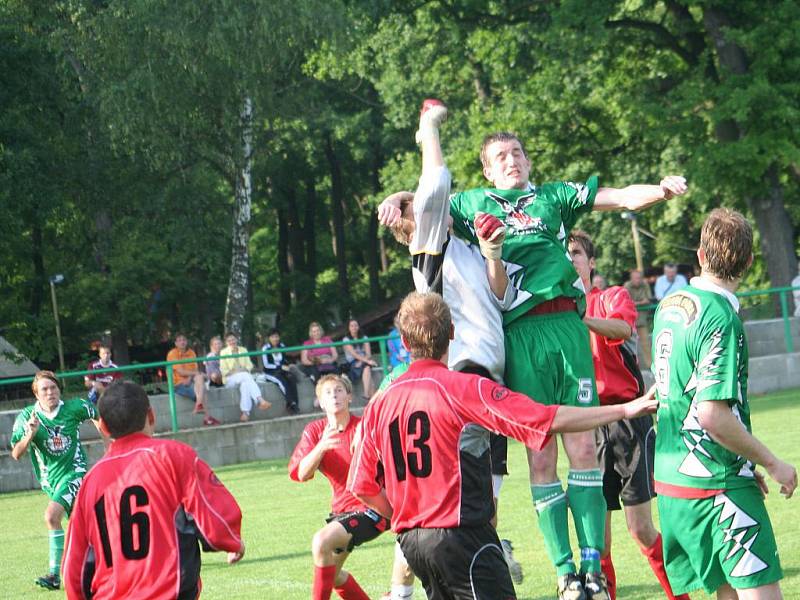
586, 286, 644, 405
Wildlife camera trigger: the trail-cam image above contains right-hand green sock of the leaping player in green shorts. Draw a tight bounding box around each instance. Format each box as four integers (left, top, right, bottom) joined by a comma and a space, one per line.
567, 469, 606, 573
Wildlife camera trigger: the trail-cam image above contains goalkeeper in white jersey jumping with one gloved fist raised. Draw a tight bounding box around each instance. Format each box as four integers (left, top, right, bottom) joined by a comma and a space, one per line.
378, 99, 523, 600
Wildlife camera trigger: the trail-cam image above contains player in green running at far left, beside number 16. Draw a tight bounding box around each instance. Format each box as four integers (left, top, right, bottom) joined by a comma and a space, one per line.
11, 371, 97, 590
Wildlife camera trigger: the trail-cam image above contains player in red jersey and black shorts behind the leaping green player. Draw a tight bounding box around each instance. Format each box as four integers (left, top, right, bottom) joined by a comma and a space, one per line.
569, 230, 689, 600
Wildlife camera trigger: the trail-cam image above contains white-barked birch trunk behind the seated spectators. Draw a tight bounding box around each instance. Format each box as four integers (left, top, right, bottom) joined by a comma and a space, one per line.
225, 96, 253, 338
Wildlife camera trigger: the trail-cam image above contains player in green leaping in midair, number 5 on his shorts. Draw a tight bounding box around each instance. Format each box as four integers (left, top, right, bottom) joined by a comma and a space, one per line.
450, 133, 687, 600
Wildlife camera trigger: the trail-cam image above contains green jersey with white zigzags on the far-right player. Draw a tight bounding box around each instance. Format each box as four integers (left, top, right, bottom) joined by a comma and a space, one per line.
652, 277, 754, 495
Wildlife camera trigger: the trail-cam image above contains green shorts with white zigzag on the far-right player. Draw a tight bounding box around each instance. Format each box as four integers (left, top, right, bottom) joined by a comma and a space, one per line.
658, 485, 783, 595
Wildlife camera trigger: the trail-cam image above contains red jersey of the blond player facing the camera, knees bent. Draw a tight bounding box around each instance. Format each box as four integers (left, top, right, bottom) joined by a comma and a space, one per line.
289, 415, 366, 514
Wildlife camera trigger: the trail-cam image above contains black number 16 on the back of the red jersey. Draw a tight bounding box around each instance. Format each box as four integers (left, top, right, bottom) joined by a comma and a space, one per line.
94, 485, 150, 567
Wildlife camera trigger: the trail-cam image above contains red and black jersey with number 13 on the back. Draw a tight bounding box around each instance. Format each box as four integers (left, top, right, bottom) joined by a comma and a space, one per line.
348, 360, 558, 533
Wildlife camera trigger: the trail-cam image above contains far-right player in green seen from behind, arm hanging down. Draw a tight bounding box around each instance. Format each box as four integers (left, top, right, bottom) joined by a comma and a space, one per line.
652, 208, 797, 600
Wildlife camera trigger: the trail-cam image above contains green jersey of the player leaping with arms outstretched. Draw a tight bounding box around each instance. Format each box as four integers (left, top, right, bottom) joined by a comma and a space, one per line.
450, 177, 597, 324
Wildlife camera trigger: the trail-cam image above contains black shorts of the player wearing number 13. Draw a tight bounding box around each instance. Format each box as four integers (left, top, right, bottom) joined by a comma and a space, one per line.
397, 523, 517, 600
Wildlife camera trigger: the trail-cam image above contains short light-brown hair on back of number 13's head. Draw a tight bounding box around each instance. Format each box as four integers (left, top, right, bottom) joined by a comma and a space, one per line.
396, 292, 452, 360
